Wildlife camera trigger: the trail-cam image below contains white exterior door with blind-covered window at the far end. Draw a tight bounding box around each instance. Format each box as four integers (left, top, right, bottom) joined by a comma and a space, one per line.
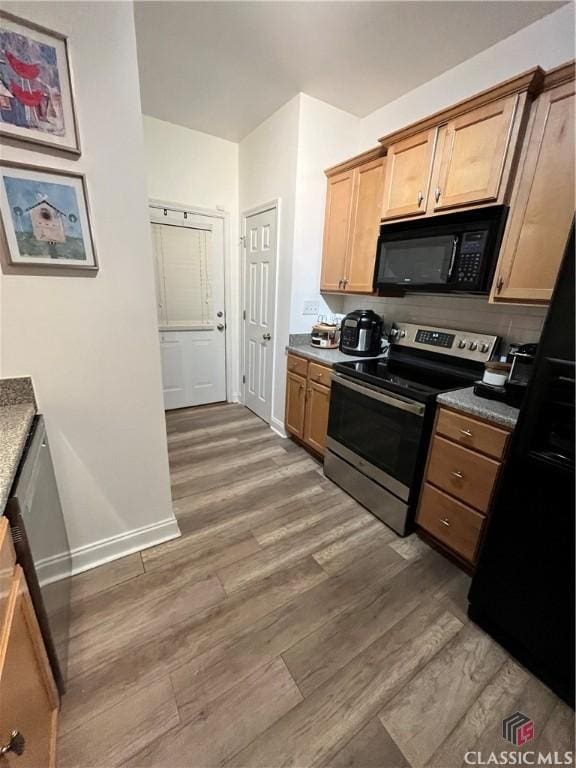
151, 207, 226, 410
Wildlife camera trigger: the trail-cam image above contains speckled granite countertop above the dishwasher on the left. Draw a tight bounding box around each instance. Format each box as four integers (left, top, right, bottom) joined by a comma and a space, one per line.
0, 377, 36, 514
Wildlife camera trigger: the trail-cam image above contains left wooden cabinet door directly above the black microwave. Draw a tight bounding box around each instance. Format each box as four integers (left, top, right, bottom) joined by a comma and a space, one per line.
382, 128, 436, 219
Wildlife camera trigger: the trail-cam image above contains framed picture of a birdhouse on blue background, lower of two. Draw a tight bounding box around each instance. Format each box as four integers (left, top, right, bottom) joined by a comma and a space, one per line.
0, 162, 98, 270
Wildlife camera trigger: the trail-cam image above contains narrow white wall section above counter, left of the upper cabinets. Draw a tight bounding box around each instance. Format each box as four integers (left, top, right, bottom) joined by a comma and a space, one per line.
290, 93, 360, 333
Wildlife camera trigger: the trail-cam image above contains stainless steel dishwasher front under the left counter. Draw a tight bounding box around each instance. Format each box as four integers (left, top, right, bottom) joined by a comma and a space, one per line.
6, 416, 72, 693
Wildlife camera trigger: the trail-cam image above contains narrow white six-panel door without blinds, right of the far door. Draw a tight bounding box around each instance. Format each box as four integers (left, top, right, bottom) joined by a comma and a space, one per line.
244, 208, 276, 423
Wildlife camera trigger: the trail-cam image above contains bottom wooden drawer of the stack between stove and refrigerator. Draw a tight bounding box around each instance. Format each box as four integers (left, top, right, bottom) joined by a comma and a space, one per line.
416, 483, 486, 563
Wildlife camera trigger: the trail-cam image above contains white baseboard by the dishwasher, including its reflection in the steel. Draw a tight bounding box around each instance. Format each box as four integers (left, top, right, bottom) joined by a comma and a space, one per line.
36, 517, 181, 585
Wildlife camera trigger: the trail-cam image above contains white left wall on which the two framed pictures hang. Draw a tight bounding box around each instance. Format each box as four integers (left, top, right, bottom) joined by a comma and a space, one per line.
0, 2, 178, 567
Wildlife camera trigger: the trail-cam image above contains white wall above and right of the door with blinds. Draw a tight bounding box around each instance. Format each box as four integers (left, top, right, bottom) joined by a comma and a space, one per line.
144, 115, 240, 400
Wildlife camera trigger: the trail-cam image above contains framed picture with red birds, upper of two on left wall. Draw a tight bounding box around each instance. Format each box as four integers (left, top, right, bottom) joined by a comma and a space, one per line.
0, 12, 80, 155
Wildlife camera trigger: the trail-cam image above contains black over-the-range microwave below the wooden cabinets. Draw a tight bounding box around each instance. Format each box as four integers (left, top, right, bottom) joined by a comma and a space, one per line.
374, 205, 508, 294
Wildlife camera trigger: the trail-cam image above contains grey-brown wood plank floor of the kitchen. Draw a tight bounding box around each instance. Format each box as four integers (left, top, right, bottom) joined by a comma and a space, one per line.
59, 405, 574, 768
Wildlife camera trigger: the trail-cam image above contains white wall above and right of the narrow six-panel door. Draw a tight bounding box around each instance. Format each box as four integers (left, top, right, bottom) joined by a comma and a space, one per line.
240, 95, 300, 428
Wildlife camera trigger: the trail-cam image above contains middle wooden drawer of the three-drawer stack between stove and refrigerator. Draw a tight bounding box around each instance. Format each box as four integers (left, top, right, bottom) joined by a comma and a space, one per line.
426, 437, 500, 512
